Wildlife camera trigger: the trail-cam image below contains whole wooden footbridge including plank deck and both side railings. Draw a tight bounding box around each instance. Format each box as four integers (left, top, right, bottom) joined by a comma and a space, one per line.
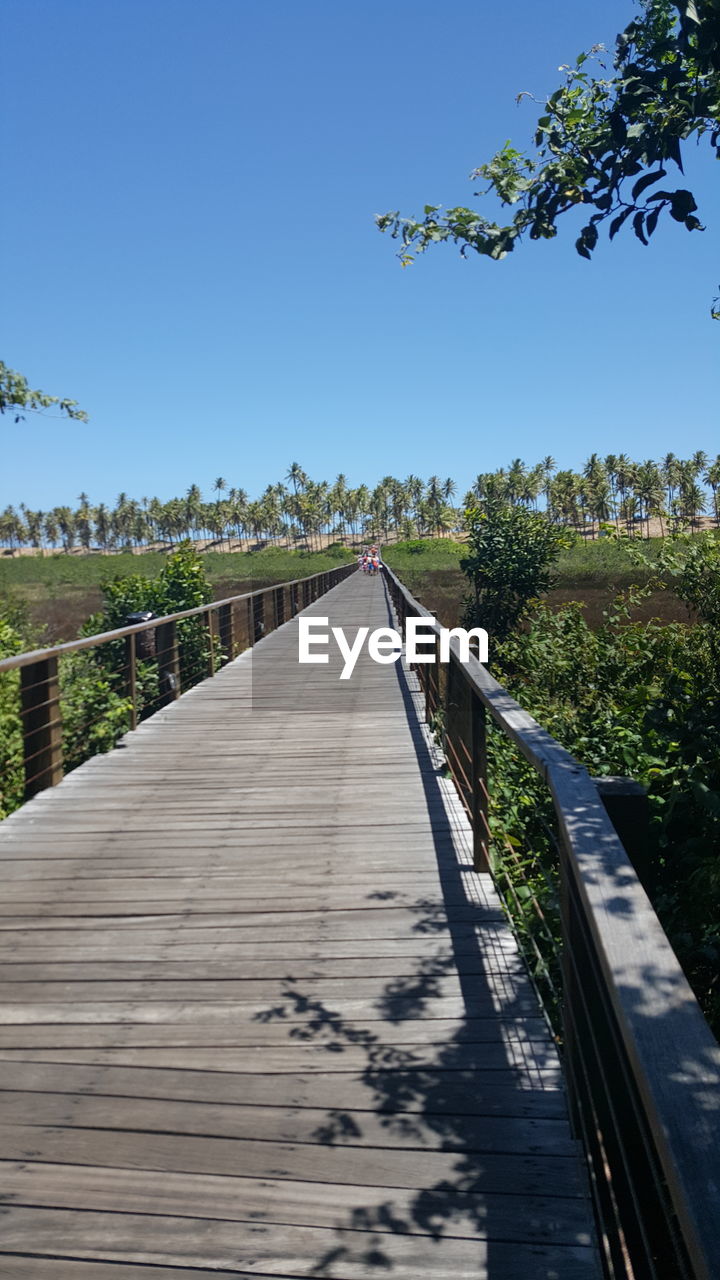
0, 568, 720, 1280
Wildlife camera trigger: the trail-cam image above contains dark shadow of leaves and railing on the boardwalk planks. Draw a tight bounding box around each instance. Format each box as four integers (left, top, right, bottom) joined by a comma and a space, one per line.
249, 663, 597, 1280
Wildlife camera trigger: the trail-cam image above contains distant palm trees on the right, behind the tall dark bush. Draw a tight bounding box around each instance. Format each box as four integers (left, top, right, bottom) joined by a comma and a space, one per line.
465, 451, 720, 538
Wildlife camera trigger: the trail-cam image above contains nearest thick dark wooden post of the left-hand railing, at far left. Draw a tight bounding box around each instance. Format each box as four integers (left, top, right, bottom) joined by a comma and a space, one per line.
20, 658, 63, 800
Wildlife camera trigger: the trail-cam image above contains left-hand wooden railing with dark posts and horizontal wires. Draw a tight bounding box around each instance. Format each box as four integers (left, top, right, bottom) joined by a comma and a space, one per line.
0, 562, 356, 800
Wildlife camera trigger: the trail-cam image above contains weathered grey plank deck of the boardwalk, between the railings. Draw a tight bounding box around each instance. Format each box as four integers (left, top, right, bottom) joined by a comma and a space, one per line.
0, 573, 598, 1280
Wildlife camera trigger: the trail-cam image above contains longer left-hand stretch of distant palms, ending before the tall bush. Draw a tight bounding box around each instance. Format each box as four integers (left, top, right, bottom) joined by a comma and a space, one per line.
0, 462, 461, 550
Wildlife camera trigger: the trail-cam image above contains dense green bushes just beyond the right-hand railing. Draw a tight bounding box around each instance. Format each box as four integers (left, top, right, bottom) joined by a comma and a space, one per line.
489, 588, 720, 1030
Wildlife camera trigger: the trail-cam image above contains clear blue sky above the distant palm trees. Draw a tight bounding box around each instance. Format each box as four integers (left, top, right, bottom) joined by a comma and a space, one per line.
0, 0, 720, 509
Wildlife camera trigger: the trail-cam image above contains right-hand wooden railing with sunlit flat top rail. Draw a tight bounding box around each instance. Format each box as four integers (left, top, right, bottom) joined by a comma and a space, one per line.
384, 567, 720, 1280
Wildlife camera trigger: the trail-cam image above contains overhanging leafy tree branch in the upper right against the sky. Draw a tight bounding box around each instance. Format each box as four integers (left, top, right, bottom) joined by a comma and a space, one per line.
377, 0, 720, 319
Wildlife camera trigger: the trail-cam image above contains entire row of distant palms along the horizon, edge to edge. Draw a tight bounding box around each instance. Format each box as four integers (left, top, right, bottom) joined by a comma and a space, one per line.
0, 452, 720, 550
